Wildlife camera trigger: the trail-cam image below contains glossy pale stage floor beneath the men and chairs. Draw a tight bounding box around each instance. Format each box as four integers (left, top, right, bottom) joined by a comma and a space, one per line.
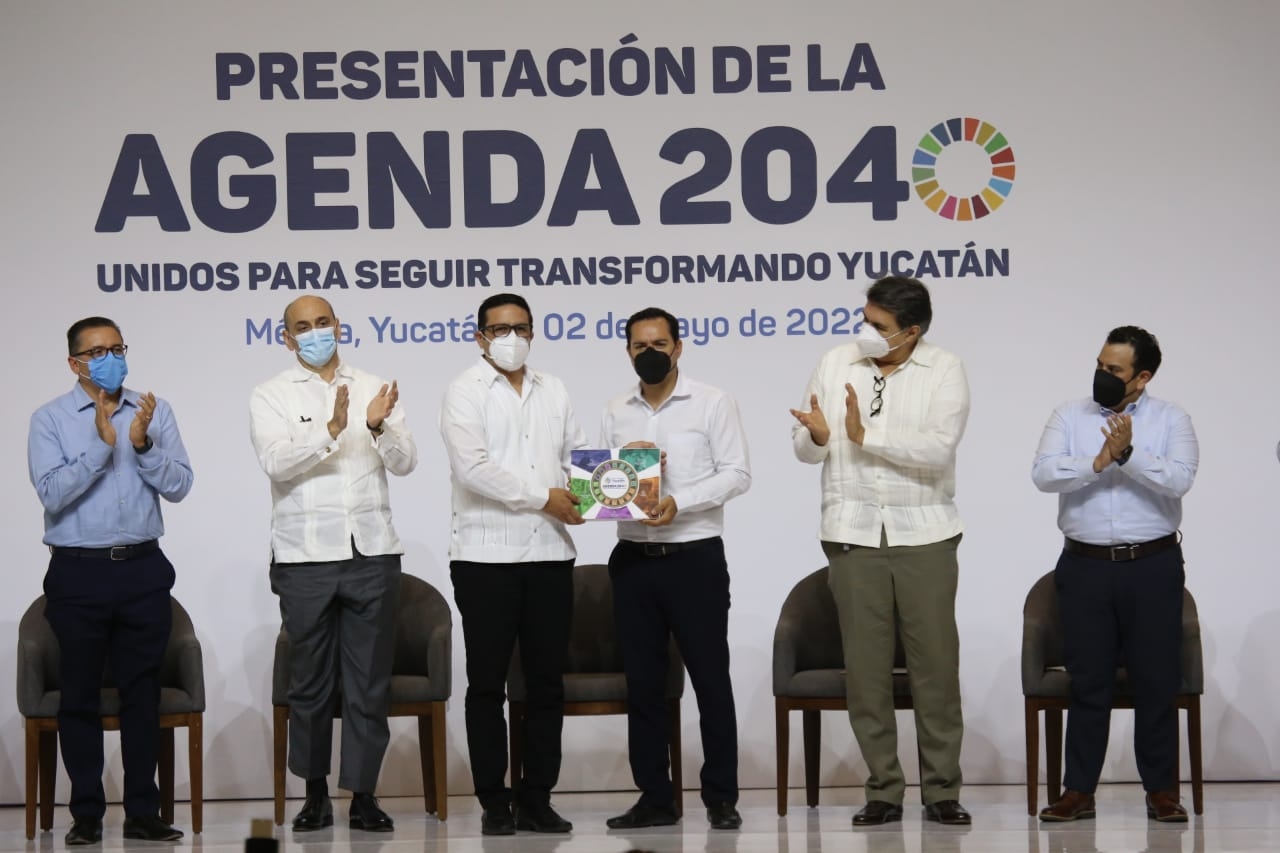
0, 784, 1280, 853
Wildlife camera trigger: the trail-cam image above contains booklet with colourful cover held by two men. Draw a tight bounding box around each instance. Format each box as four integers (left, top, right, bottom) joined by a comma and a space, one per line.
570, 447, 662, 521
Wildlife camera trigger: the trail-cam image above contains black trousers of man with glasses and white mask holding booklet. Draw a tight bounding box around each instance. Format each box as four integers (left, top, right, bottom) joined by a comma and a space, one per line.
449, 560, 573, 808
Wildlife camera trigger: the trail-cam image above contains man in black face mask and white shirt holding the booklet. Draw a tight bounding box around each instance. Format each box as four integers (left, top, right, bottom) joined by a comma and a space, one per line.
600, 307, 751, 830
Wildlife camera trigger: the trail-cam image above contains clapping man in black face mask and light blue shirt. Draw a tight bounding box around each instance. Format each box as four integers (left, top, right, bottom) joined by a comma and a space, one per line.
1032, 325, 1199, 821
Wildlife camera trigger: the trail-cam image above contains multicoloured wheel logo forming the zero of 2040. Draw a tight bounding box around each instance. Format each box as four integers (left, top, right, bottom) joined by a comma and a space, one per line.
911, 118, 1015, 222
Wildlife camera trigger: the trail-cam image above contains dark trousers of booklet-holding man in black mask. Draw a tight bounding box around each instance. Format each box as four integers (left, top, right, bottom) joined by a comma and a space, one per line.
609, 538, 737, 808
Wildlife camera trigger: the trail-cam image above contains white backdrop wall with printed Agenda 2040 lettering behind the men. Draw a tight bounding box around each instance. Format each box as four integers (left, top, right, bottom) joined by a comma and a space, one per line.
0, 0, 1280, 802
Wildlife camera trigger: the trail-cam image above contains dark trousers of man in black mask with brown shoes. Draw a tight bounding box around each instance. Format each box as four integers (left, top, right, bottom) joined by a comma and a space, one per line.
1053, 547, 1185, 793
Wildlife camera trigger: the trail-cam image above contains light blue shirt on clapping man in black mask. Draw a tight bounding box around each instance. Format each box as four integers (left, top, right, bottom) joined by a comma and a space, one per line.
1032, 392, 1199, 546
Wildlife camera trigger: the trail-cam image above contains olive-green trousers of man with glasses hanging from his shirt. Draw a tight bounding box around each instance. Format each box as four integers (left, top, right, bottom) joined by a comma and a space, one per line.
822, 535, 964, 806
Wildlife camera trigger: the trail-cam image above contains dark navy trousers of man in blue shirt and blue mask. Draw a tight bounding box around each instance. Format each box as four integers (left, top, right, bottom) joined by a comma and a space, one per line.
45, 551, 174, 818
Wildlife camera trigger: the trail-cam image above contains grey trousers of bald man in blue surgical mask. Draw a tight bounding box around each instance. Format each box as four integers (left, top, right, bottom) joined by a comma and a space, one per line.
271, 555, 401, 794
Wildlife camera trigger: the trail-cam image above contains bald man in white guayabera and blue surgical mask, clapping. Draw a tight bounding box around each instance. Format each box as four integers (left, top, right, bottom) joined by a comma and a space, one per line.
250, 296, 417, 833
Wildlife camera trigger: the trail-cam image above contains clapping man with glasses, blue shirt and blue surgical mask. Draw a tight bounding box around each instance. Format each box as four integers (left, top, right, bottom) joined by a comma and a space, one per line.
27, 316, 192, 845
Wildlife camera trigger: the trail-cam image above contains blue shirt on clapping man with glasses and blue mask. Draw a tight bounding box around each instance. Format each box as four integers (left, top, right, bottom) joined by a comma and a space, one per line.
27, 383, 192, 548
